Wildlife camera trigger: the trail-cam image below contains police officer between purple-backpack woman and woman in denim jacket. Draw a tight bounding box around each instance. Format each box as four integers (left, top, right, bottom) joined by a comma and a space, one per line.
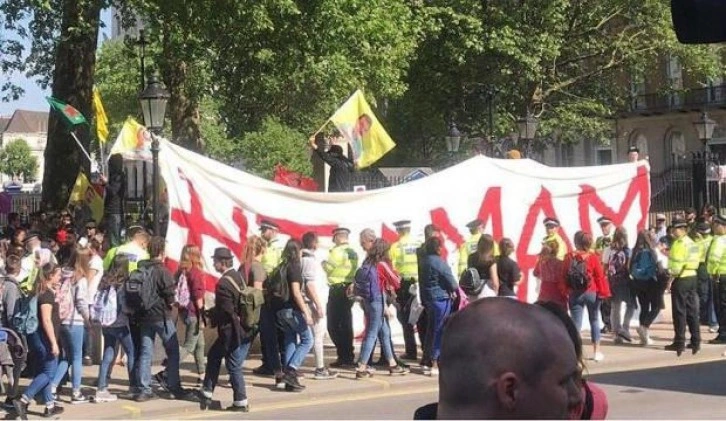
389, 221, 425, 361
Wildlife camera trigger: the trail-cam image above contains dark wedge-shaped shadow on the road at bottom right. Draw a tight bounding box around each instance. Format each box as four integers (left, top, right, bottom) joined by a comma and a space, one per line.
588, 361, 726, 396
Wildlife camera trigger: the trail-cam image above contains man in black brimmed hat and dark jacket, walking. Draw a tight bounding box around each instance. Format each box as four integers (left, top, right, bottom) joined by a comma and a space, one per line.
201, 247, 252, 412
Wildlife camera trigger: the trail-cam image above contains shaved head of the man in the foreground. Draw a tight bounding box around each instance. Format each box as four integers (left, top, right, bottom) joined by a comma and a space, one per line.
415, 298, 582, 419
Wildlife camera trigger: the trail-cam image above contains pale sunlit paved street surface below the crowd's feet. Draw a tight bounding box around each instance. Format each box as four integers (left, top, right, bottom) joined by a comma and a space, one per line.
11, 324, 726, 420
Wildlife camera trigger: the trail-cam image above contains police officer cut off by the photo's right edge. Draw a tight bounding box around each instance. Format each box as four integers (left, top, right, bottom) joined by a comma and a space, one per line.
706, 215, 726, 344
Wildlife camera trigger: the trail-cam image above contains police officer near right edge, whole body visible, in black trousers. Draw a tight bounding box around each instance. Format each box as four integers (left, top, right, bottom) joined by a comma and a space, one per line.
665, 219, 701, 356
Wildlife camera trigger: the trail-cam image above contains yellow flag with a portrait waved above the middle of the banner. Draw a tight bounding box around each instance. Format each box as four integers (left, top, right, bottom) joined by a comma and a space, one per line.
330, 90, 396, 168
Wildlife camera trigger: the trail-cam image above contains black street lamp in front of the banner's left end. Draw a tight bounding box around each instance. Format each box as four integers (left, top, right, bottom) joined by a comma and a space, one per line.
139, 76, 170, 235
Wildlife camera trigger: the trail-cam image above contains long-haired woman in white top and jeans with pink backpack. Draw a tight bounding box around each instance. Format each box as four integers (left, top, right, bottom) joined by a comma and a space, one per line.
52, 247, 91, 404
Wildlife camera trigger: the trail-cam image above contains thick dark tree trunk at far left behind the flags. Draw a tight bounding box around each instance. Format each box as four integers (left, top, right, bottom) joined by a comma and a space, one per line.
42, 0, 101, 210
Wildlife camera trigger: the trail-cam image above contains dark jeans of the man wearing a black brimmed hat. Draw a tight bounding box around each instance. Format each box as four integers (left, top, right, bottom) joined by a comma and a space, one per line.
202, 337, 251, 403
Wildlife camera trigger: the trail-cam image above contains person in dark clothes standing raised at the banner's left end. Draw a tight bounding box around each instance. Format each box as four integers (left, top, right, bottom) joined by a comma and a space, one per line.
101, 154, 126, 247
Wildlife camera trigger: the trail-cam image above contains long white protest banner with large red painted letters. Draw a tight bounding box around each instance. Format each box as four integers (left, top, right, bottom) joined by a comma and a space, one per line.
160, 141, 650, 301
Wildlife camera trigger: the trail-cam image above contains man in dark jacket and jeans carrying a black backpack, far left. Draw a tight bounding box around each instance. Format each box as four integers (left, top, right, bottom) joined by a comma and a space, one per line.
133, 237, 196, 402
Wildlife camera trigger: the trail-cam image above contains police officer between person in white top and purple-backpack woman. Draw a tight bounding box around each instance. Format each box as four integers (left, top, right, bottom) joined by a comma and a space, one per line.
323, 228, 358, 368
